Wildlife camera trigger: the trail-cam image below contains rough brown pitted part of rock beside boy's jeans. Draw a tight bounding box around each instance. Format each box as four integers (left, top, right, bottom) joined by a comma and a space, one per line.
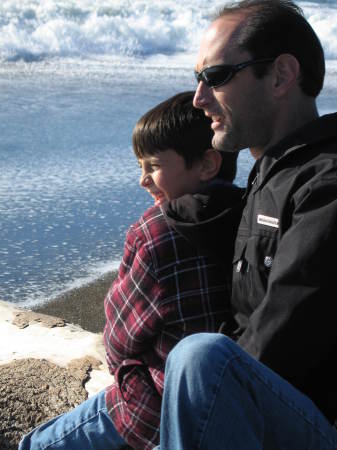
0, 358, 87, 449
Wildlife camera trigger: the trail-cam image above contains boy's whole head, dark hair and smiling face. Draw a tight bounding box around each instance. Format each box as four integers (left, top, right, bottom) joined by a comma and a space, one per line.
132, 91, 237, 203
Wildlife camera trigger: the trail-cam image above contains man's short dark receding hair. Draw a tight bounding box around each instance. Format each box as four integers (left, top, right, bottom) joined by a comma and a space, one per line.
215, 0, 325, 97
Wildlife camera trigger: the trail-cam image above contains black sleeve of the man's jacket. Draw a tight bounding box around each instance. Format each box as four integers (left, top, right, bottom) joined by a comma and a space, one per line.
238, 174, 337, 384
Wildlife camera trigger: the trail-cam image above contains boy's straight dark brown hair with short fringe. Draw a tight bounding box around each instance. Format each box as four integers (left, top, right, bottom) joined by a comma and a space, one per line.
132, 91, 238, 181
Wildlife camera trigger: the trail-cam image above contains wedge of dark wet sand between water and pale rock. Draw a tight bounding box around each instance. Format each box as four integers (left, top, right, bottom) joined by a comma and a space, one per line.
30, 271, 118, 333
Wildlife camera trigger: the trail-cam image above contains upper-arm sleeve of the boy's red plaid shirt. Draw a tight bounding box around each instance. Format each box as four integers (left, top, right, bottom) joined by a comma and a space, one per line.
104, 227, 162, 373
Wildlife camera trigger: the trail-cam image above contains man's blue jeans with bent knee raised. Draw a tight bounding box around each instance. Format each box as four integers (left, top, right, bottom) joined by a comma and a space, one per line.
156, 333, 337, 450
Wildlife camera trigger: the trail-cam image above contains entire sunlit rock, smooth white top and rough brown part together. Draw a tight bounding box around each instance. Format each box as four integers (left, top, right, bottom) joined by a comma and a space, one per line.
0, 301, 113, 450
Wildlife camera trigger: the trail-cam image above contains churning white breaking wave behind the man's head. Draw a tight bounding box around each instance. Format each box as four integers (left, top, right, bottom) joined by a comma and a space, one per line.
0, 0, 337, 62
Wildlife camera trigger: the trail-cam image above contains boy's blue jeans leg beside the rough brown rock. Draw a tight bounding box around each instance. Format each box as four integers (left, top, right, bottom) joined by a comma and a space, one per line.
18, 391, 126, 450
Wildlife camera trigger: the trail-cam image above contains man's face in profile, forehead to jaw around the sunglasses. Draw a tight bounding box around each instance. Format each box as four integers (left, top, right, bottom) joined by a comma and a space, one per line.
194, 14, 274, 153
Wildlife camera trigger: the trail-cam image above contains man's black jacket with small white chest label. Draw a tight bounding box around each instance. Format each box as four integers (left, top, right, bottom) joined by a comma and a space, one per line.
230, 114, 337, 420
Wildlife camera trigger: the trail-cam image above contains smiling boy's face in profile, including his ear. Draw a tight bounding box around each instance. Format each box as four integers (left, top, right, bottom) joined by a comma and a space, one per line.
138, 149, 202, 205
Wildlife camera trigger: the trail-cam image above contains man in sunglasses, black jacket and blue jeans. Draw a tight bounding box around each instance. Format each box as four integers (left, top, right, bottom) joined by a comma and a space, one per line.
156, 0, 337, 450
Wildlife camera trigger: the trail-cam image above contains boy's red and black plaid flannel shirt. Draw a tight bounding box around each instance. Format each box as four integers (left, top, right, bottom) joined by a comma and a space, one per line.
104, 207, 231, 449
